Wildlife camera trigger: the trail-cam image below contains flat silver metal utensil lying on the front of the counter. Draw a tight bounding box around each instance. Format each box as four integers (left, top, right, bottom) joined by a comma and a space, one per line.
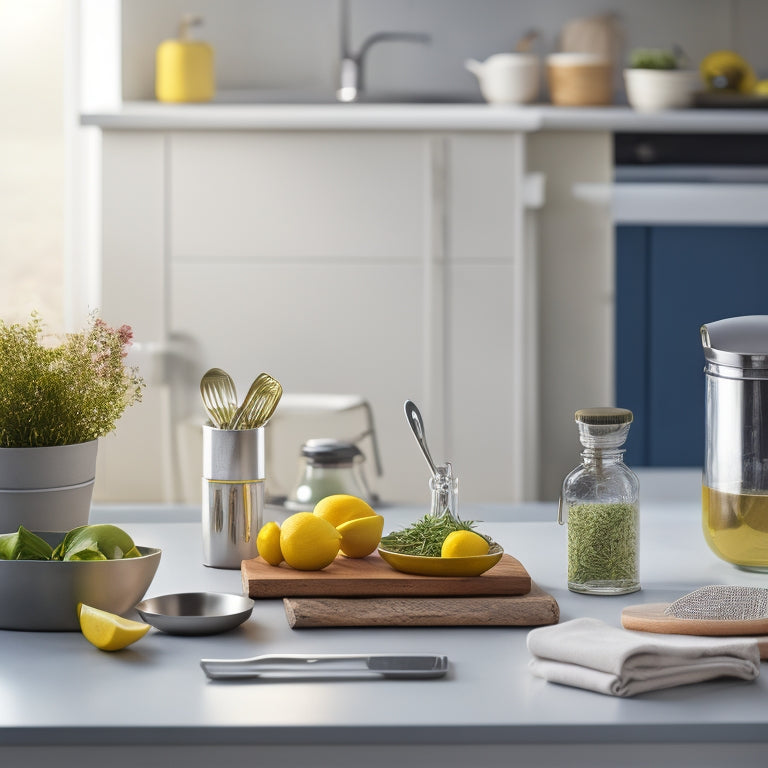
200, 653, 448, 680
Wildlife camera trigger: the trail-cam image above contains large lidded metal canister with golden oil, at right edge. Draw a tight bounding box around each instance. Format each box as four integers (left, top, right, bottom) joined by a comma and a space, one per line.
701, 315, 768, 571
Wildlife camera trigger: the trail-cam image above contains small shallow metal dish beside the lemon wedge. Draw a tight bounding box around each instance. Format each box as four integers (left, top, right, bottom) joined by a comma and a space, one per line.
136, 592, 254, 635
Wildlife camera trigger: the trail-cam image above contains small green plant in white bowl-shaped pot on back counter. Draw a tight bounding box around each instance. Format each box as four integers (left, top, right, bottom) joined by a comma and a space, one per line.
624, 48, 701, 112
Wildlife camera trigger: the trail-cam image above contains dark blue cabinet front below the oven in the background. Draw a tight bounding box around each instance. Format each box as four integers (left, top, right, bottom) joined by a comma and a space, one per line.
616, 226, 768, 467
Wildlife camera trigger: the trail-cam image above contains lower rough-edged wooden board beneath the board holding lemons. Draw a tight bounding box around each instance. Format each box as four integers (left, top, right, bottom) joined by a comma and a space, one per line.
283, 584, 560, 629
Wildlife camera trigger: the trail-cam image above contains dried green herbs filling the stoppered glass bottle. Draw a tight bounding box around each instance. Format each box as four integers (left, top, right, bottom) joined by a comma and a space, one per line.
568, 503, 638, 584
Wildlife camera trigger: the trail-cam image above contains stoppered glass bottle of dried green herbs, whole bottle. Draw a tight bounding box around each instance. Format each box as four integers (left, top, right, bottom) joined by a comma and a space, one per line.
557, 408, 640, 595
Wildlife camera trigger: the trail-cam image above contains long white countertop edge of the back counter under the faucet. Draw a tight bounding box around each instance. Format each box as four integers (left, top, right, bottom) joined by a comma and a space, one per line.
80, 102, 768, 133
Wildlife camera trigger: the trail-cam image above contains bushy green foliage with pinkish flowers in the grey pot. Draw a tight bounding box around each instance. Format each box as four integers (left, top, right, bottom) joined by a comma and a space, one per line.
0, 314, 144, 448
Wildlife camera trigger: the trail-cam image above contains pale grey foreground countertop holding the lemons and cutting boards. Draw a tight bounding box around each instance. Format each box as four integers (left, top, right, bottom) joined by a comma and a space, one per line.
0, 493, 768, 768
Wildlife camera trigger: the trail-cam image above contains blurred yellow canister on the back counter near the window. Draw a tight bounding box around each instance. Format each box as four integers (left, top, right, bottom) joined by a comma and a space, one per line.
155, 16, 216, 102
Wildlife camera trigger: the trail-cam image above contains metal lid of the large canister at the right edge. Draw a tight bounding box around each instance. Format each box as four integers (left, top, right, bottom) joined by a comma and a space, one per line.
700, 315, 768, 370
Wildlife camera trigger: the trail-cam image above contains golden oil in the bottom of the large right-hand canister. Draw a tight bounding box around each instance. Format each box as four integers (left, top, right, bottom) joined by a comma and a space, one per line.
702, 485, 768, 572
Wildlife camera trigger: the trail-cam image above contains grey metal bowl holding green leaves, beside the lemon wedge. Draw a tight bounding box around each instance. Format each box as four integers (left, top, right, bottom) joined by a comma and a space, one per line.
0, 532, 160, 631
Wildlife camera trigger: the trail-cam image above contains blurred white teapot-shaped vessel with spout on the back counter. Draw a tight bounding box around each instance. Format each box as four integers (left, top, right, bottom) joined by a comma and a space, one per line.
465, 53, 540, 104
